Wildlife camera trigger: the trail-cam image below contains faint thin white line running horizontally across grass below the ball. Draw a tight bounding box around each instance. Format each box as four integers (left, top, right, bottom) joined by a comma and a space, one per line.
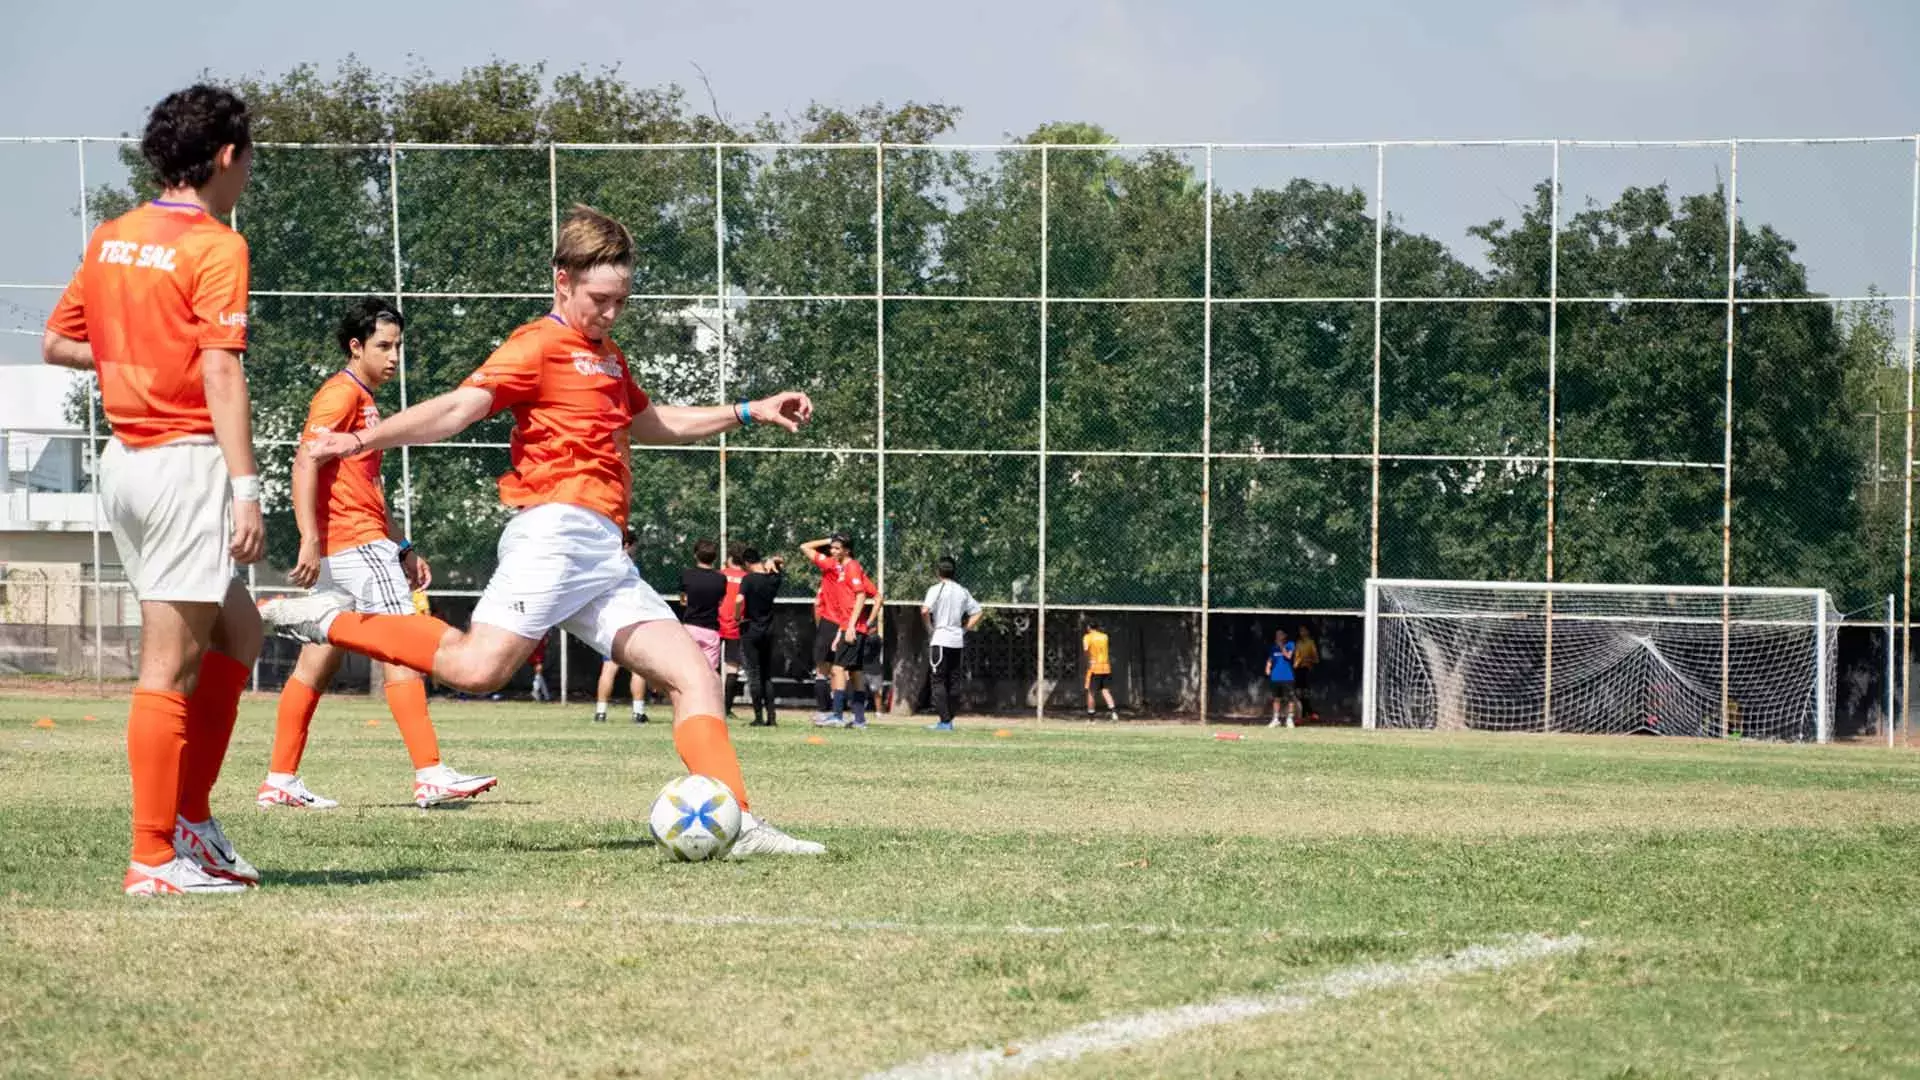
120, 903, 1374, 938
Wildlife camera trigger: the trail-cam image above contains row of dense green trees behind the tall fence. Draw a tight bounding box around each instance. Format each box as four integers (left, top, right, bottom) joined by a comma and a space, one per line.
73, 58, 1905, 607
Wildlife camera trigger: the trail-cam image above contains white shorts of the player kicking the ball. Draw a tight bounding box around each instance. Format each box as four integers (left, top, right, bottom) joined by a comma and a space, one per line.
472, 503, 674, 655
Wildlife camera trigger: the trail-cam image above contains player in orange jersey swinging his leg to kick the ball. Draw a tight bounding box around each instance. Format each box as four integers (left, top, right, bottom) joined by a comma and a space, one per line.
261, 206, 826, 859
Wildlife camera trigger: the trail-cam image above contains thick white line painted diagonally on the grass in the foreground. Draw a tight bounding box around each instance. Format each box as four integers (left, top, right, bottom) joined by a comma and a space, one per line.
868, 934, 1586, 1080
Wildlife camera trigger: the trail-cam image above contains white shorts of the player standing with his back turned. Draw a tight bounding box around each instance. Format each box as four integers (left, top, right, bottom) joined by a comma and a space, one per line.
100, 438, 234, 603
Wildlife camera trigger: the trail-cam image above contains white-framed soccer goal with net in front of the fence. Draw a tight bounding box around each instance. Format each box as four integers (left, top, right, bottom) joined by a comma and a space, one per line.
1361, 578, 1839, 742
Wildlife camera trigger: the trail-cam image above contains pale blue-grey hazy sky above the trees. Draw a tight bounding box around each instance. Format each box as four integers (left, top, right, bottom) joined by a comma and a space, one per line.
0, 0, 1920, 423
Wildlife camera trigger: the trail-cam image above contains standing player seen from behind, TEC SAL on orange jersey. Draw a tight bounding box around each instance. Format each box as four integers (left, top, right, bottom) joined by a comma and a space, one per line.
40, 85, 263, 896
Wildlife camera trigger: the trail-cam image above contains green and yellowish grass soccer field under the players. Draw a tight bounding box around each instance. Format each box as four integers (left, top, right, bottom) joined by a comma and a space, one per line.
0, 698, 1920, 1078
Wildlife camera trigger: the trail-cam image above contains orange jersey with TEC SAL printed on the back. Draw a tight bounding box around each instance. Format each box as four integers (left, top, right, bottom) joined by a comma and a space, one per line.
46, 202, 248, 448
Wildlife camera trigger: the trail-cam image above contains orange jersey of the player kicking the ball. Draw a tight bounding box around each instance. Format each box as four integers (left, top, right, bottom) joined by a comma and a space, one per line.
467, 315, 647, 527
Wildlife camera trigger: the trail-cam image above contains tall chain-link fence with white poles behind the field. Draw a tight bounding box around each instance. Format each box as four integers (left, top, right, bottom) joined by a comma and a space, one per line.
0, 138, 1920, 713
